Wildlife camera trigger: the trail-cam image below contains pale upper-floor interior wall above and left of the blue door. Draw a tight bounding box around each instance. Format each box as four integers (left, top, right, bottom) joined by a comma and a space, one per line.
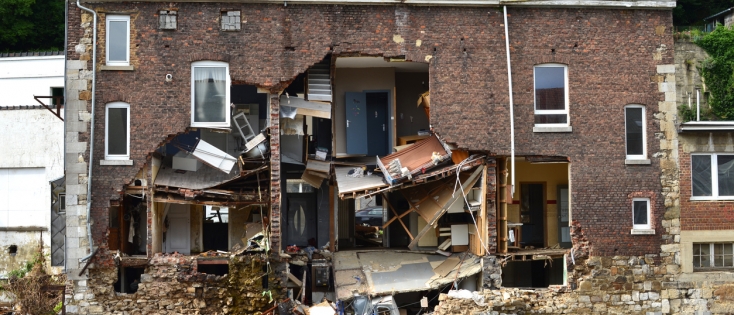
333, 68, 395, 155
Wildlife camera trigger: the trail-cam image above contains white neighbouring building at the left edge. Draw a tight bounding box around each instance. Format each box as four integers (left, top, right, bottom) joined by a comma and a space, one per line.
0, 52, 65, 278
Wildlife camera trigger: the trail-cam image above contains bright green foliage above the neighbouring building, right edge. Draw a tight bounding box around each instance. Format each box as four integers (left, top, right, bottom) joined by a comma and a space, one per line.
696, 25, 734, 120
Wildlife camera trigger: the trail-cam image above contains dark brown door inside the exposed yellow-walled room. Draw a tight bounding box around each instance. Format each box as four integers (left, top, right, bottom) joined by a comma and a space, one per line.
520, 184, 545, 247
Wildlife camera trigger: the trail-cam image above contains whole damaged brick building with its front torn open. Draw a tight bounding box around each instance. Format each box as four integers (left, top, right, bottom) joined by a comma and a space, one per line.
66, 0, 724, 314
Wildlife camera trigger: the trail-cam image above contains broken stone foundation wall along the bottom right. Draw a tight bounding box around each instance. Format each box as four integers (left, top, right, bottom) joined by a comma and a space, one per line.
434, 255, 734, 315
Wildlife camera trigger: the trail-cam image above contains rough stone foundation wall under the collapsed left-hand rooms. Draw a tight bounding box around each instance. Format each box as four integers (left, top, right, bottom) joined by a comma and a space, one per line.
67, 254, 283, 315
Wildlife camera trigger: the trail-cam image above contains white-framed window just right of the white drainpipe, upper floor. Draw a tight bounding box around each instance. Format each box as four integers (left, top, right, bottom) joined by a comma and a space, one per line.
534, 64, 568, 126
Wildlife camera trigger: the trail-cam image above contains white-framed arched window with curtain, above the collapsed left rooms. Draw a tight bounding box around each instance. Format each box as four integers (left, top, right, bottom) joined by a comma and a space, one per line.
191, 61, 230, 128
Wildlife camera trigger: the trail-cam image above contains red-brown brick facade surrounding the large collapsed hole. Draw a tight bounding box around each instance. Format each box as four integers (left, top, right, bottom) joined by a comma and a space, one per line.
75, 3, 672, 255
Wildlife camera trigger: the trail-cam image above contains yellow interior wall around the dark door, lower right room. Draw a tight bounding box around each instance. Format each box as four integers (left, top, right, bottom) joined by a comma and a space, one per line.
507, 161, 568, 246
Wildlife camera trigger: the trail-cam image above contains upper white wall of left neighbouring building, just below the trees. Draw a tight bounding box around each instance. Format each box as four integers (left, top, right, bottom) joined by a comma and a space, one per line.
0, 56, 64, 106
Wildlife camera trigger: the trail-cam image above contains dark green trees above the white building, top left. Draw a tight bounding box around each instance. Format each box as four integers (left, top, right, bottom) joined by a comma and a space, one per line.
0, 0, 64, 52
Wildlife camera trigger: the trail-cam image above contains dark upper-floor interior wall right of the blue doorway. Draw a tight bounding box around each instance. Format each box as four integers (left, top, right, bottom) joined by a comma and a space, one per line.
395, 72, 429, 137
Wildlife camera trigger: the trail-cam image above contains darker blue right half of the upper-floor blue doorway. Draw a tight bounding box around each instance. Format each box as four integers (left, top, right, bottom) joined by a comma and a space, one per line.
366, 92, 390, 156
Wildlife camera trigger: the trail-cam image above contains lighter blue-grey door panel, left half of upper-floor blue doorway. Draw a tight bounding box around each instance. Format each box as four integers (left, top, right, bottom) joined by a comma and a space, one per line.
345, 92, 367, 155
